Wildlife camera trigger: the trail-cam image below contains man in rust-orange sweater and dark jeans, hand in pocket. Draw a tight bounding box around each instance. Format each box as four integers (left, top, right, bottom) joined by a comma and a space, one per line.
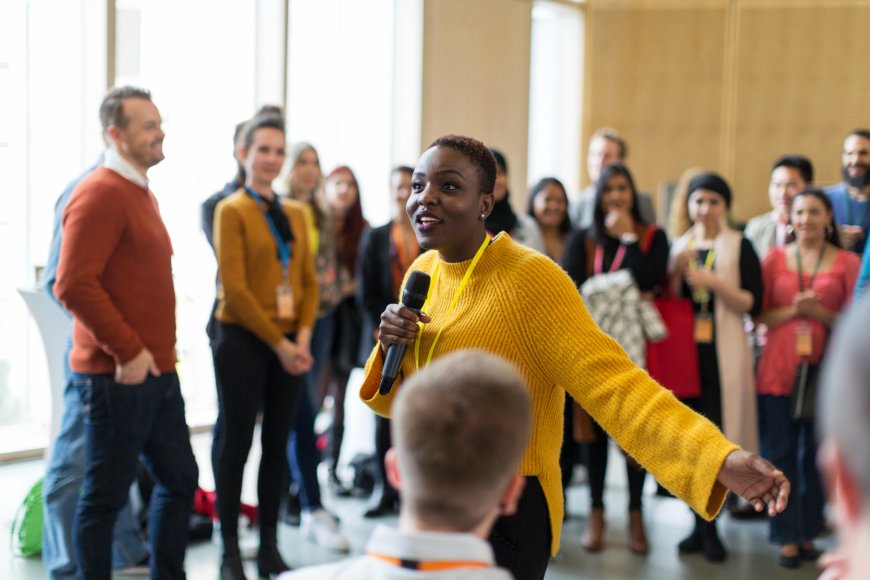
55, 87, 198, 580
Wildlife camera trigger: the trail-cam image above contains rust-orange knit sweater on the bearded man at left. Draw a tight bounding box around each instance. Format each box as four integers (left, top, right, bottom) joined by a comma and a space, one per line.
54, 167, 175, 374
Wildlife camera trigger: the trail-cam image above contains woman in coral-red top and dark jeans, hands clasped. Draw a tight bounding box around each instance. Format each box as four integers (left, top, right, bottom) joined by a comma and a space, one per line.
756, 189, 860, 568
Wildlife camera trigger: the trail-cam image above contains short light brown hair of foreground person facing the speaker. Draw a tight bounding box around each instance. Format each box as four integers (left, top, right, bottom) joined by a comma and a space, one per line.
392, 350, 532, 531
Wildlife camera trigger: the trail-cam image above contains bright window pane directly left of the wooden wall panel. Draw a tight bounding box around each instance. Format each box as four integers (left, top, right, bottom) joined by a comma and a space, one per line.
287, 0, 422, 225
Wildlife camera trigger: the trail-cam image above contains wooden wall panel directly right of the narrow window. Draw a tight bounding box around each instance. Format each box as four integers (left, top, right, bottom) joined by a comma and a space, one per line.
581, 3, 728, 204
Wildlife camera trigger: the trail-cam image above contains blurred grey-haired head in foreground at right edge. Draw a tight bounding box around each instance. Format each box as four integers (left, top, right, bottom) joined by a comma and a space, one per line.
820, 295, 870, 560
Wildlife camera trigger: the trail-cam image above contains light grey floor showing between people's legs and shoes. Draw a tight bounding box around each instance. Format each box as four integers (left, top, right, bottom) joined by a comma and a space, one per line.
0, 435, 832, 580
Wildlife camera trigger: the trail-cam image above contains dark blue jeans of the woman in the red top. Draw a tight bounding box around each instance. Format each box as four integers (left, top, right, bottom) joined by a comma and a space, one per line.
758, 395, 825, 544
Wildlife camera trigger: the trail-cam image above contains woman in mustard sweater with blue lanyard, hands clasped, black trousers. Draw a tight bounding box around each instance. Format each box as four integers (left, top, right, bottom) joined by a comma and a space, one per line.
213, 116, 318, 580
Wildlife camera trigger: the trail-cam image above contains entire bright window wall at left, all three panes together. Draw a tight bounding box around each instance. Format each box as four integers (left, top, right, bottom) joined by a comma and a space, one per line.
0, 0, 422, 456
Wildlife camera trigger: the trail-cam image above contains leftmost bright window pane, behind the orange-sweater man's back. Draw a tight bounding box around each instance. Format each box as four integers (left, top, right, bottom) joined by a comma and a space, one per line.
0, 0, 106, 453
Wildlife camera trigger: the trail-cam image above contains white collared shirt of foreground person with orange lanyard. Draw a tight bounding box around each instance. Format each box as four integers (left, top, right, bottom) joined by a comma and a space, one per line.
280, 526, 511, 580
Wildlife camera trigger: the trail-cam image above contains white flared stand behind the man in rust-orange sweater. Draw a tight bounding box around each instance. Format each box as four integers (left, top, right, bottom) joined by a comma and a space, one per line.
18, 288, 72, 450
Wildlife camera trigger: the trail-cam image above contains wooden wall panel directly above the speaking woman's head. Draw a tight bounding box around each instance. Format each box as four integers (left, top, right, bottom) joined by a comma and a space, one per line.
421, 0, 532, 198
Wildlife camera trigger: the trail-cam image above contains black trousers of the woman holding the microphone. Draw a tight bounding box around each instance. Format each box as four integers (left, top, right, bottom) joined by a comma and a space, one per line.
489, 477, 553, 580
